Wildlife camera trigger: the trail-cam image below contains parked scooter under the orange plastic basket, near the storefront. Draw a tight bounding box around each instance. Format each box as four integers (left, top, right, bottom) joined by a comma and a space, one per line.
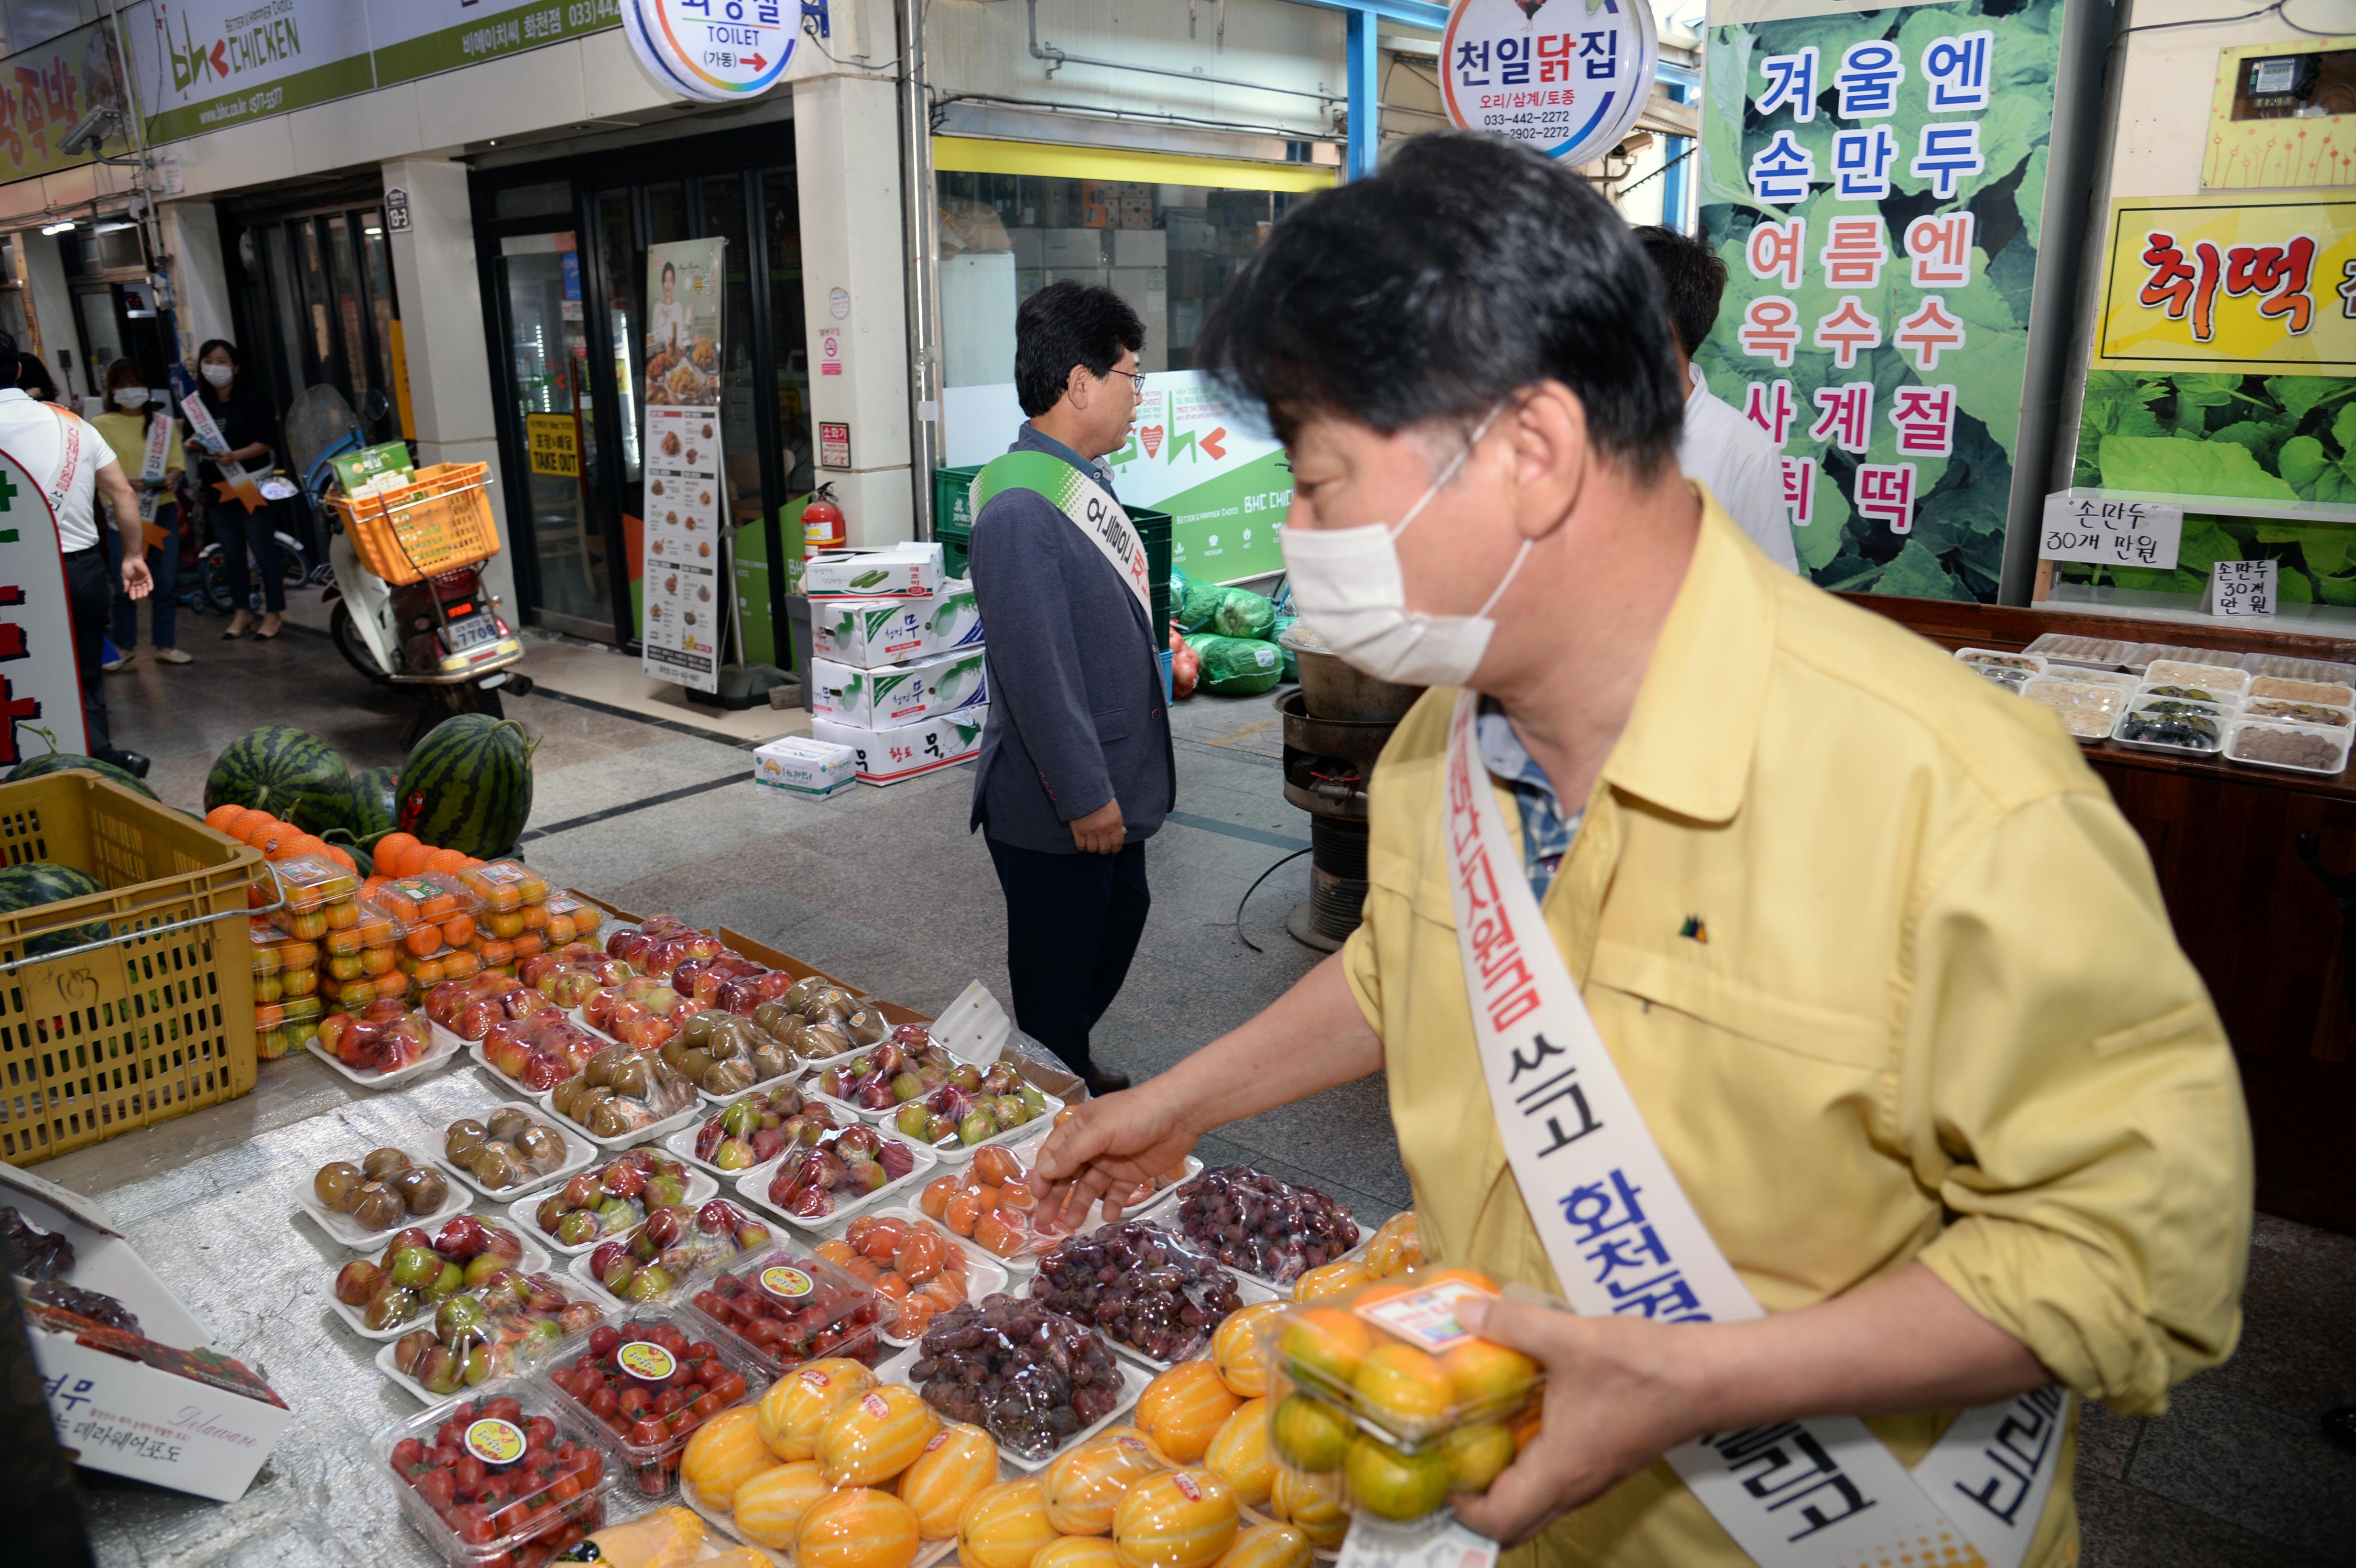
285, 386, 533, 744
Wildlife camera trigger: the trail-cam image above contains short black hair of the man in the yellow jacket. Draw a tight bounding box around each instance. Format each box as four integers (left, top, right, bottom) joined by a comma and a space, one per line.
1194, 132, 1685, 478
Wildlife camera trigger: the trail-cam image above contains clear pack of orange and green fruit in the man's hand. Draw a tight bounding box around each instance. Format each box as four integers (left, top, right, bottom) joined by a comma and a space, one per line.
1258, 1269, 1546, 1521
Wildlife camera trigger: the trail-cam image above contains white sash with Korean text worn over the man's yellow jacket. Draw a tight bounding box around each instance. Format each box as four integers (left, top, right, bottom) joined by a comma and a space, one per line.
1447, 692, 2069, 1568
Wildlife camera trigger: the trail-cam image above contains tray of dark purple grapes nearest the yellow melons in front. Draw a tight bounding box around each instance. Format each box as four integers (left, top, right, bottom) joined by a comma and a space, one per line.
909, 1295, 1122, 1459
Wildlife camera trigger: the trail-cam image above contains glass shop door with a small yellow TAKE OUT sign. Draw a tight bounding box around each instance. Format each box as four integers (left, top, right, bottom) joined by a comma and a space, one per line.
497, 231, 612, 643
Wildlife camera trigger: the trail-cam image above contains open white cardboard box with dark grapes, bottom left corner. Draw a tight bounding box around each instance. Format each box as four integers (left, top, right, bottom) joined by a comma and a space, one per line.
0, 1165, 294, 1502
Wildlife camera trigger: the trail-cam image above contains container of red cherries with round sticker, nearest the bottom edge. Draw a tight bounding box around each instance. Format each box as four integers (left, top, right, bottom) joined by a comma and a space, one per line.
372, 1377, 612, 1568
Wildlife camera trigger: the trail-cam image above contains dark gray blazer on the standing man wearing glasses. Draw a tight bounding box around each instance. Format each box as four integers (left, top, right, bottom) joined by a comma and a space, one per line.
968, 424, 1178, 855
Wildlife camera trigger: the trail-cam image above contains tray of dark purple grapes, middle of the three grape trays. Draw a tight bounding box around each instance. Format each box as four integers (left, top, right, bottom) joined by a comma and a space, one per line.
1032, 1220, 1244, 1361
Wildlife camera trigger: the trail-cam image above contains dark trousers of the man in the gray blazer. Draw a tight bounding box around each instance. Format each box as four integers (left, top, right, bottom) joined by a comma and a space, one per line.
982, 829, 1152, 1071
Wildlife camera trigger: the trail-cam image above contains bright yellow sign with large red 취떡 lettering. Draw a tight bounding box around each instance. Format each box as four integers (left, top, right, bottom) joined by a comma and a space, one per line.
2094, 193, 2356, 377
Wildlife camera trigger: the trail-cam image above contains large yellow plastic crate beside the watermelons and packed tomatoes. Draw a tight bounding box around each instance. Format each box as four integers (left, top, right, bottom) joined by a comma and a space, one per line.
0, 770, 262, 1165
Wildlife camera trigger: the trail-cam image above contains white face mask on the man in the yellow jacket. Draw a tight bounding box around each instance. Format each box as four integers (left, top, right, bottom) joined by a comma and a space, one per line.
1284, 403, 1529, 685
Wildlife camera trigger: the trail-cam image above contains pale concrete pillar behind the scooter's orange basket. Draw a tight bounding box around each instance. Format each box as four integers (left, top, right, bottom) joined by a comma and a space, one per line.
384, 158, 523, 626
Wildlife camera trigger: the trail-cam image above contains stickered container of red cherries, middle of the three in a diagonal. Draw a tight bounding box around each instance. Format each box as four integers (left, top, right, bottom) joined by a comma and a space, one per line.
540, 1309, 766, 1497
